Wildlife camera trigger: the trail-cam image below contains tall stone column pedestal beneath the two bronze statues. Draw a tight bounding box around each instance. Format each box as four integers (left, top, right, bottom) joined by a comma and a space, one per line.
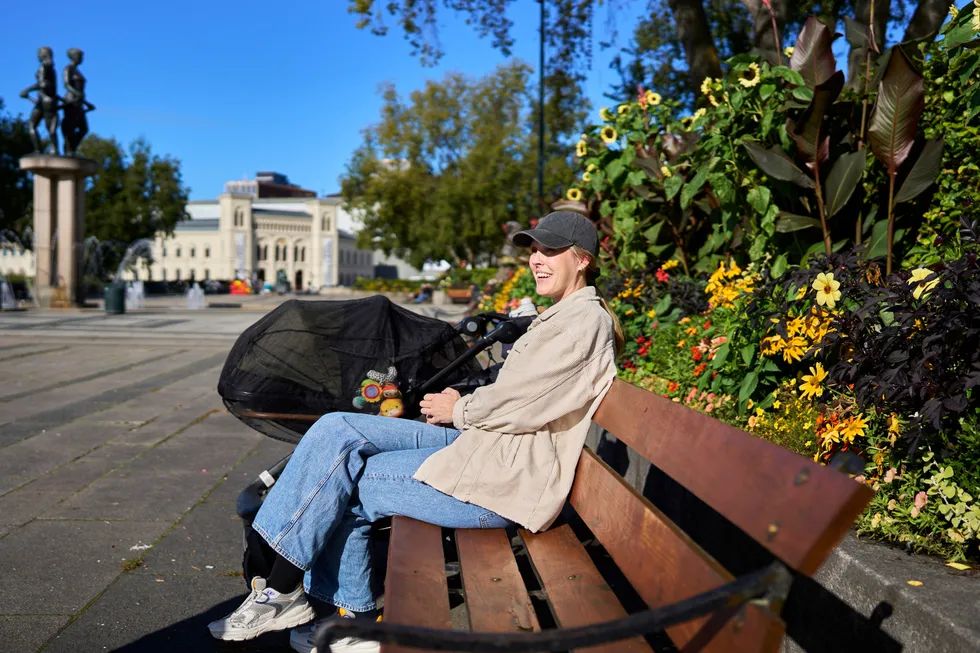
20, 154, 99, 308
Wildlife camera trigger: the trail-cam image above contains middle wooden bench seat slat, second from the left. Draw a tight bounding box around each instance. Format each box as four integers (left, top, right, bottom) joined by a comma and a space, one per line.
456, 528, 541, 633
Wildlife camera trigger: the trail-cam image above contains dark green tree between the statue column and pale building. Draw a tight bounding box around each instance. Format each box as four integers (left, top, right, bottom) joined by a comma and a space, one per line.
80, 135, 188, 248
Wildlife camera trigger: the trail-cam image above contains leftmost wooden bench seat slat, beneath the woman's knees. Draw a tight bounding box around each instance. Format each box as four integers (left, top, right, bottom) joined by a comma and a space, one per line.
381, 517, 453, 653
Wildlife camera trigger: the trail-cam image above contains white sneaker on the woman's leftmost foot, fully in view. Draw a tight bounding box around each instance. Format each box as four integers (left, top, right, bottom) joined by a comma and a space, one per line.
208, 576, 316, 642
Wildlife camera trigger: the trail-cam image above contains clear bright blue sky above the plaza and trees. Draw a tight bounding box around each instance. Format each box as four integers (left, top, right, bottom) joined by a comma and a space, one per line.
0, 0, 645, 199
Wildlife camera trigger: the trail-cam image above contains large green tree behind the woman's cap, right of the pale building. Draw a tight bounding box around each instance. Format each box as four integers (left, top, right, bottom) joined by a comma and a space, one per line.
341, 62, 585, 265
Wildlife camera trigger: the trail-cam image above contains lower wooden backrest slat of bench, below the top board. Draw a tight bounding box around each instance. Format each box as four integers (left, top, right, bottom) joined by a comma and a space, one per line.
569, 449, 784, 653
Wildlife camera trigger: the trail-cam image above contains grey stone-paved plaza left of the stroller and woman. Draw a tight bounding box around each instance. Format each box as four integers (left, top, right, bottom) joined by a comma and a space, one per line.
0, 304, 468, 653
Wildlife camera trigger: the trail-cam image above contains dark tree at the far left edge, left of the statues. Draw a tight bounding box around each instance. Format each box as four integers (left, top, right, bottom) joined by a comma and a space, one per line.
0, 98, 34, 234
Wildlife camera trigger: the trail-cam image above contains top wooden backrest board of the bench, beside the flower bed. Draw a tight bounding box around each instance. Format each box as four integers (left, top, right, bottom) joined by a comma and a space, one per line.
594, 379, 872, 575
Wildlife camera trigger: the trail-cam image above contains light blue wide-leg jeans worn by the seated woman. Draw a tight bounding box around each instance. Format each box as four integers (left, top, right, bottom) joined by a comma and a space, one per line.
252, 413, 510, 612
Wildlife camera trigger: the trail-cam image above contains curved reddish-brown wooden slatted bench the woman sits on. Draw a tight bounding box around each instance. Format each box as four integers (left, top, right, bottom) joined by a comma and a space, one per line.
318, 380, 872, 653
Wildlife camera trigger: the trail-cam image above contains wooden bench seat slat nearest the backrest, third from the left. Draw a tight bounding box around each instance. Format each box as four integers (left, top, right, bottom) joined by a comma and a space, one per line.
520, 525, 653, 653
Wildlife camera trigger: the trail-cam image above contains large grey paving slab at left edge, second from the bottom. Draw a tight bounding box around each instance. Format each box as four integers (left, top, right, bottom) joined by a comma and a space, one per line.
0, 520, 169, 615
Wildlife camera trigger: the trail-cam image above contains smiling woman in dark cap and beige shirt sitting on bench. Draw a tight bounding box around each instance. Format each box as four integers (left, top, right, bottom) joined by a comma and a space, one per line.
209, 211, 623, 653
